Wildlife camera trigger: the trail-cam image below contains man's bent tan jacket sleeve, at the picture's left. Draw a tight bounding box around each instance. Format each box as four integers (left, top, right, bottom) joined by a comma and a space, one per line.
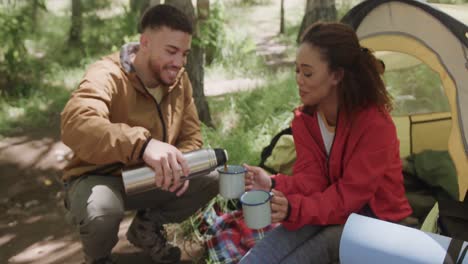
61, 62, 151, 165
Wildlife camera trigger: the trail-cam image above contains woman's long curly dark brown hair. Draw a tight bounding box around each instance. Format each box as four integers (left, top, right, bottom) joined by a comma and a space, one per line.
300, 22, 392, 114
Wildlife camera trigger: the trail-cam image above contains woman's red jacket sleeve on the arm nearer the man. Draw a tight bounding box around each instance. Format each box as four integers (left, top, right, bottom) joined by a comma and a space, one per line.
273, 117, 328, 195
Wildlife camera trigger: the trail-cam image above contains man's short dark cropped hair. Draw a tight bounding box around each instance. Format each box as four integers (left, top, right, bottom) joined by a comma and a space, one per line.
138, 4, 193, 35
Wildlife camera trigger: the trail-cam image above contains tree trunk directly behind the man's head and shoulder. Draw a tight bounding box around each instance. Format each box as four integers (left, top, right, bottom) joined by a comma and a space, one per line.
165, 0, 213, 127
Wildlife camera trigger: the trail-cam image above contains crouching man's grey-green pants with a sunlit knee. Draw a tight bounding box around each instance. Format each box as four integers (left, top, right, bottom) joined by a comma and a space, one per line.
65, 171, 219, 259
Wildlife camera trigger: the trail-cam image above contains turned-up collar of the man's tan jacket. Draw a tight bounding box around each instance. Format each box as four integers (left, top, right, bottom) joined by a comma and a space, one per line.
119, 42, 185, 94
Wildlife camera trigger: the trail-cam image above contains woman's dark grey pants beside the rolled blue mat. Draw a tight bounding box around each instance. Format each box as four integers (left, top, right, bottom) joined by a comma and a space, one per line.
239, 225, 343, 264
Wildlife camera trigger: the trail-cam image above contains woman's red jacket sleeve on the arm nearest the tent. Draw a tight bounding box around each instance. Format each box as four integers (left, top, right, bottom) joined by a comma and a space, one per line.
283, 118, 398, 230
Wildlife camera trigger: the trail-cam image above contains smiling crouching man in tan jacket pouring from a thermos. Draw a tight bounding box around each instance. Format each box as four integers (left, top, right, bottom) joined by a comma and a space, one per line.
61, 5, 218, 263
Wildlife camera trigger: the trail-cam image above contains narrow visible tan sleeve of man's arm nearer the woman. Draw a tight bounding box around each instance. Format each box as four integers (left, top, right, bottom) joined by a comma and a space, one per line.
176, 73, 203, 152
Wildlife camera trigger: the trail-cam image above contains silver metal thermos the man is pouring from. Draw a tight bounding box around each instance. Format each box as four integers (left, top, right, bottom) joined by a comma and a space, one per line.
122, 149, 228, 195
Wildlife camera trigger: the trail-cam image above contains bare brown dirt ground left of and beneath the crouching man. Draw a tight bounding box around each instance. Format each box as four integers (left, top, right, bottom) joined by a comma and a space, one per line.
0, 108, 207, 264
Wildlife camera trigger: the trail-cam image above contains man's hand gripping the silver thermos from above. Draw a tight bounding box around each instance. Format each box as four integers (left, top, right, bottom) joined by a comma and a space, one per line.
143, 139, 190, 196
